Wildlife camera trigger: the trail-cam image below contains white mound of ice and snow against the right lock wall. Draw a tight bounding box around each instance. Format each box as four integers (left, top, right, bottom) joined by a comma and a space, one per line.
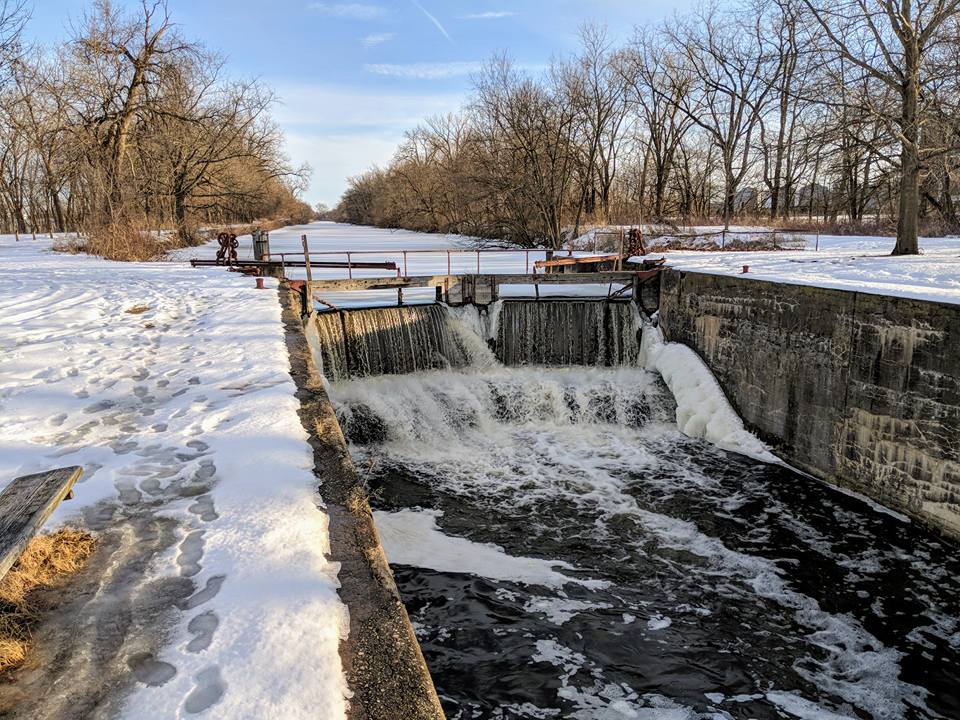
640, 323, 780, 463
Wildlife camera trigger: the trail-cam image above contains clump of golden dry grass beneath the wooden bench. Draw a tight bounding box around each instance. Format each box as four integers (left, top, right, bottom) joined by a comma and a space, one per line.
0, 528, 96, 671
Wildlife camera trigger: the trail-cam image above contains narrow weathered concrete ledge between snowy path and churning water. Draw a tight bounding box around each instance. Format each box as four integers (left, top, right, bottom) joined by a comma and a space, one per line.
281, 284, 444, 720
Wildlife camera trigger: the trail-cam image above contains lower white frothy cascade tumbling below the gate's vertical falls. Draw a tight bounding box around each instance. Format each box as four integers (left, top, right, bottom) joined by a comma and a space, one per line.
333, 367, 675, 450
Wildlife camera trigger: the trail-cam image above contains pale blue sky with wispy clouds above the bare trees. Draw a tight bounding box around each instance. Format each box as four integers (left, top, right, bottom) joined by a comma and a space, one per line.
28, 0, 696, 205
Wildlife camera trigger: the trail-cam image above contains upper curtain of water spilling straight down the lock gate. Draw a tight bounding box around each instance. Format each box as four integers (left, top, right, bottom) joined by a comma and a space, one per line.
314, 300, 640, 382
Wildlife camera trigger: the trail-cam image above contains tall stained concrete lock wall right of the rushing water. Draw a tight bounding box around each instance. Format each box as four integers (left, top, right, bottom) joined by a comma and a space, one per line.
660, 270, 960, 538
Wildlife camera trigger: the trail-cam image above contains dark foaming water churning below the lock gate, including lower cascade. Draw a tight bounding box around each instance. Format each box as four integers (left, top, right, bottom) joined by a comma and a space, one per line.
324, 310, 960, 720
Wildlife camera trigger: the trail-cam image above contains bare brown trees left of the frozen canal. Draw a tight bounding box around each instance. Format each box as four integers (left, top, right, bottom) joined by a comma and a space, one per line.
0, 0, 312, 252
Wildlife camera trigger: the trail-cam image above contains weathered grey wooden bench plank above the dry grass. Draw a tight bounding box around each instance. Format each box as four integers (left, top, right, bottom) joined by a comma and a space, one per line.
0, 466, 83, 577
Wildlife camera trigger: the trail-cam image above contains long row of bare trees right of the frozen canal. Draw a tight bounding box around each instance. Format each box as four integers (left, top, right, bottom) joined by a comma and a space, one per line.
335, 0, 960, 254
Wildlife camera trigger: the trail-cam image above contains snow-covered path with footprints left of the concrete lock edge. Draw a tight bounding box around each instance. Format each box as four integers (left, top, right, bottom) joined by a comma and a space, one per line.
0, 237, 348, 718
